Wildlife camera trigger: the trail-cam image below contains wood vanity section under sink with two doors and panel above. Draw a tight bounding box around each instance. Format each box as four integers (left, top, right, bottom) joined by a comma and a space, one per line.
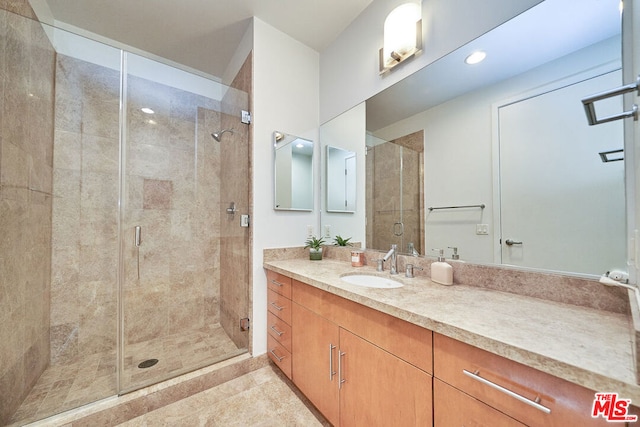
291, 280, 433, 427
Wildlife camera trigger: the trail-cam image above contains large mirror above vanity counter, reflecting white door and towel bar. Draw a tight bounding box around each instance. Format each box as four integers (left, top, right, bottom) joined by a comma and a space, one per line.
321, 0, 626, 276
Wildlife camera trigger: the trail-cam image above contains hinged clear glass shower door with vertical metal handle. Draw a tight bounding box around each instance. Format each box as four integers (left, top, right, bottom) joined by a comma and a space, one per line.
119, 54, 249, 392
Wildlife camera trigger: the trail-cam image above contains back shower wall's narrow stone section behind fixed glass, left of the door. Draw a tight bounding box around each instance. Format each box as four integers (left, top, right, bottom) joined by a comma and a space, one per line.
51, 55, 120, 368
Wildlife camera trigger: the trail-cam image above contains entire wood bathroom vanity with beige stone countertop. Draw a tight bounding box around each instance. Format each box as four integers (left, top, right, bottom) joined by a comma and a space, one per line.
264, 254, 640, 426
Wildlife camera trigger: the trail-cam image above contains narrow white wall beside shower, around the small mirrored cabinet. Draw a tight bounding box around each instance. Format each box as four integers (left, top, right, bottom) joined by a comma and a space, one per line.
252, 18, 320, 356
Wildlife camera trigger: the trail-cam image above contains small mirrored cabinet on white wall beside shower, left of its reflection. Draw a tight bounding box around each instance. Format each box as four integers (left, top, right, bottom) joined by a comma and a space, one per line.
273, 131, 313, 211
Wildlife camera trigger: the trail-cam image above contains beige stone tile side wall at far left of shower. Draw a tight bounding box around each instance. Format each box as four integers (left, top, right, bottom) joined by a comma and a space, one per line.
0, 5, 55, 424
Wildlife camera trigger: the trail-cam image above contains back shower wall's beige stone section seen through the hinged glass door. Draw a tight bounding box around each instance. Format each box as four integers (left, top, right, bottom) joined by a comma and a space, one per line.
123, 76, 221, 351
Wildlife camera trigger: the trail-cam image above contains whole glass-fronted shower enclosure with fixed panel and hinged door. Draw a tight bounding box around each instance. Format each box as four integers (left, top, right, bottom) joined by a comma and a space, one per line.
0, 9, 250, 425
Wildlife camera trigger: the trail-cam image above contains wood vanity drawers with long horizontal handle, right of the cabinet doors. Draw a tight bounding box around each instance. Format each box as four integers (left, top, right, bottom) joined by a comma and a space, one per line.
433, 333, 611, 427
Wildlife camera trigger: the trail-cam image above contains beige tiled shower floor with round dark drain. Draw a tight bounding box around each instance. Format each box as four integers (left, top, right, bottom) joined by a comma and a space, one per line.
10, 326, 244, 426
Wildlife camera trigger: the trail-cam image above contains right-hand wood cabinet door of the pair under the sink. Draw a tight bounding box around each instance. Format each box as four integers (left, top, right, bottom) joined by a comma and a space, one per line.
339, 329, 432, 427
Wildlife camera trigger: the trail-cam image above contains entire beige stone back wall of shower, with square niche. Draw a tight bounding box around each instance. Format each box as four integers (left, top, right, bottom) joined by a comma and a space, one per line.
52, 52, 229, 363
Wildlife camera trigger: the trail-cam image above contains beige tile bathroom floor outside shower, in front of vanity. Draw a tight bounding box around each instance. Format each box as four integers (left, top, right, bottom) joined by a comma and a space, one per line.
114, 365, 330, 427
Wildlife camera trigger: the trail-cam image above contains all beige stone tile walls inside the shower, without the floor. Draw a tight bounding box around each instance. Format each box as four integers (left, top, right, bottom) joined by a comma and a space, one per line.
0, 0, 251, 424
